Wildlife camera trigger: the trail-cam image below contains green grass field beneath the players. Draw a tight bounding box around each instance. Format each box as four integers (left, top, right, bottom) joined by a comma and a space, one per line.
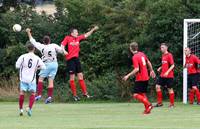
0, 102, 200, 129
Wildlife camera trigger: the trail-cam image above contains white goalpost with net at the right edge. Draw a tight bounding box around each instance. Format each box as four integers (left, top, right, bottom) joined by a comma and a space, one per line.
183, 19, 200, 104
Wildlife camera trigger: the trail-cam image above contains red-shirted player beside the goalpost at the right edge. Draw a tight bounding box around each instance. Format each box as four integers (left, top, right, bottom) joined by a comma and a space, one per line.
184, 48, 200, 105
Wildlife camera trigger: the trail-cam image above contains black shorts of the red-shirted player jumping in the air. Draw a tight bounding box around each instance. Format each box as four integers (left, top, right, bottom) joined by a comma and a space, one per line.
67, 58, 82, 74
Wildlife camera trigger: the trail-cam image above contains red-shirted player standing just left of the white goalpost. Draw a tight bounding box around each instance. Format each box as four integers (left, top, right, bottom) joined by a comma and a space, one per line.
154, 43, 175, 108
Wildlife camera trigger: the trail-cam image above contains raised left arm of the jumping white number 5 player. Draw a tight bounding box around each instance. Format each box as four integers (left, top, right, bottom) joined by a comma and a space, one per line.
26, 28, 44, 51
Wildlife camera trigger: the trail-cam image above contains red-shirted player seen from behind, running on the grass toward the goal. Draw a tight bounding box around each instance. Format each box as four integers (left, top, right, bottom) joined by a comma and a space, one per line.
123, 42, 155, 114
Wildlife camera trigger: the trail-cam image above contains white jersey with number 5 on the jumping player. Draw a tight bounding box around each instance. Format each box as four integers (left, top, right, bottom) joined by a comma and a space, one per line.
30, 38, 63, 63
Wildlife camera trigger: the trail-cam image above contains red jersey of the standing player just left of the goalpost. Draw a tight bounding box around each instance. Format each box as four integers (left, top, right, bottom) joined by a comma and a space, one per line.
160, 52, 174, 78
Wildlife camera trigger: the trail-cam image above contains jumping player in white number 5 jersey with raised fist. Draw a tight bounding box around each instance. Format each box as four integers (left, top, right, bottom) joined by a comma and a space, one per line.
26, 28, 63, 104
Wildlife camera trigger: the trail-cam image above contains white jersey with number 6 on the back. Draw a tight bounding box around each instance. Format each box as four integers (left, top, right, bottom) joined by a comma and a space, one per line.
16, 52, 46, 83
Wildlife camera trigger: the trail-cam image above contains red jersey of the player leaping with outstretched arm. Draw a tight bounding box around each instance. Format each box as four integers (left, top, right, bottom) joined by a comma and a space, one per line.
61, 35, 85, 60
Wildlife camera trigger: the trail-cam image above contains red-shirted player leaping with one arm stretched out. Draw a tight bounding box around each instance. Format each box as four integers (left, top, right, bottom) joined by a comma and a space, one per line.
61, 26, 99, 101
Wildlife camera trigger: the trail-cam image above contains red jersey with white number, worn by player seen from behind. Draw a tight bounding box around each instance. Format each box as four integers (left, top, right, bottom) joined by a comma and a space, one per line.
132, 52, 149, 81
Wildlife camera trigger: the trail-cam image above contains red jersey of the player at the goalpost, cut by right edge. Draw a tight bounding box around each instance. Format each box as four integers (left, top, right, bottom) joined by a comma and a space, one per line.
185, 54, 200, 74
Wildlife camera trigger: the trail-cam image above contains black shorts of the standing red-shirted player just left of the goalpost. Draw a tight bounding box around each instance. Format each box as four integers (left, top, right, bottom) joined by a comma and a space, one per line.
156, 77, 174, 88
